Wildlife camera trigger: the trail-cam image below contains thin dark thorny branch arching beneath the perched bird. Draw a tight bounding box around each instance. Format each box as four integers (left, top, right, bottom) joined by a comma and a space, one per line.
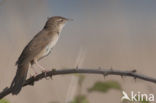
0, 68, 156, 99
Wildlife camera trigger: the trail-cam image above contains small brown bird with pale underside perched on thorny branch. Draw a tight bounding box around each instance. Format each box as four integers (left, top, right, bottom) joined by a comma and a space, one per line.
10, 16, 72, 95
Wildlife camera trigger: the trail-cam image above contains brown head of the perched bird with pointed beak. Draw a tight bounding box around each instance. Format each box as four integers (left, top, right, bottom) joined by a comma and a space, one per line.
45, 16, 72, 31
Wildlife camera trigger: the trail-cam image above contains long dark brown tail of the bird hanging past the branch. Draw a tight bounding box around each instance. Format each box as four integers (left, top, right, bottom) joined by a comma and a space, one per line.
10, 63, 29, 95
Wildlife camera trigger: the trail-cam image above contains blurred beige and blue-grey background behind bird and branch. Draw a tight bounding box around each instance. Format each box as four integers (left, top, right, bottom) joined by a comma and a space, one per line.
0, 0, 156, 103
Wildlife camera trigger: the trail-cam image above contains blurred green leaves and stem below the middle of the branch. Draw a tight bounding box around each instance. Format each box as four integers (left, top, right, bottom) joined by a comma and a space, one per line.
70, 75, 121, 103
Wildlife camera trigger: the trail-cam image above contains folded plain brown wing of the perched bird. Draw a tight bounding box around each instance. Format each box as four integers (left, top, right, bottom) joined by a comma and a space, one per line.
16, 30, 50, 64
